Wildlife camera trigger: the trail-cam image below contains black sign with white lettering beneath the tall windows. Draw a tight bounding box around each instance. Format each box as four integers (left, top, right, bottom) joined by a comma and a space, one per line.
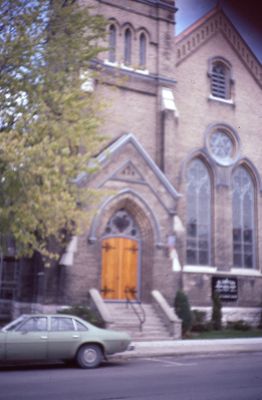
212, 276, 238, 301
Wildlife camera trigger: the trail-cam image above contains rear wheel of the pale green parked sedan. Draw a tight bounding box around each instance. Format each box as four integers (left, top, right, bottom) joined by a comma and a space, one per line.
76, 344, 103, 368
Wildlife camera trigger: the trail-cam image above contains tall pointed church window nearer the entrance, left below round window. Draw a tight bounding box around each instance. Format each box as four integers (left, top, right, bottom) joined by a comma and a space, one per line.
186, 159, 211, 265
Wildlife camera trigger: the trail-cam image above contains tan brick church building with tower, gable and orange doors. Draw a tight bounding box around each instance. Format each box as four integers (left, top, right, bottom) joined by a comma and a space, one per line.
1, 0, 262, 320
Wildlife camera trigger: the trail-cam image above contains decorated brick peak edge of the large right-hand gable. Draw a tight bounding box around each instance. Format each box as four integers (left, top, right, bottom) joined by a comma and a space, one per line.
175, 6, 262, 86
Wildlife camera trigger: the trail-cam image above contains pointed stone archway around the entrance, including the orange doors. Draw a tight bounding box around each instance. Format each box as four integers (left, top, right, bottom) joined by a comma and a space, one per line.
96, 195, 159, 302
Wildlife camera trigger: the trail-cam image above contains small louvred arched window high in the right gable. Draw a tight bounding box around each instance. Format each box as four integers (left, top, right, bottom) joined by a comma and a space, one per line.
210, 61, 231, 99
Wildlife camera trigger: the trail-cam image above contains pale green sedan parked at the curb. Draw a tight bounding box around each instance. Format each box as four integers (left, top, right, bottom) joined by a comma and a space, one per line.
0, 314, 132, 368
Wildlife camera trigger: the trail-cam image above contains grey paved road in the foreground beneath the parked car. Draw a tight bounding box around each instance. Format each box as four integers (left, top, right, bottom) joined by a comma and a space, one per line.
0, 353, 262, 400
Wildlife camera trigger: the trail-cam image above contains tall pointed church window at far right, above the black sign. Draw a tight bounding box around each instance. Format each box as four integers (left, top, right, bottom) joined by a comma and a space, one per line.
232, 167, 255, 268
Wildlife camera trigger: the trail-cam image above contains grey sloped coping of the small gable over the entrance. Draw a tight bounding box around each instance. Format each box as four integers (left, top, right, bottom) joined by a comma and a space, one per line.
96, 133, 180, 199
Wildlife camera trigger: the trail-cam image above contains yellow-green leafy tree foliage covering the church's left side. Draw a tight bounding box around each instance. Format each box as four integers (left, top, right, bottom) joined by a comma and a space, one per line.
0, 0, 106, 256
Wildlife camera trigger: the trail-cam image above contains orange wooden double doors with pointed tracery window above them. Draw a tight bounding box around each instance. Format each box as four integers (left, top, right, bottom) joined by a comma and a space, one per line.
101, 209, 141, 300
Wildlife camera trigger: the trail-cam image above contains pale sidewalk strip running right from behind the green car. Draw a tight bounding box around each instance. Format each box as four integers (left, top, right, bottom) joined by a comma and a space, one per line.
117, 338, 262, 358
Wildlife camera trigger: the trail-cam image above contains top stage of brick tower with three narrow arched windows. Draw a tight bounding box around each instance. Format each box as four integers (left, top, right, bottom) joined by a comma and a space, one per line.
89, 0, 176, 79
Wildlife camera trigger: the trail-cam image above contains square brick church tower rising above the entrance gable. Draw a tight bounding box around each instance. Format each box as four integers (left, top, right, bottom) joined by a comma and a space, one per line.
87, 0, 176, 171
